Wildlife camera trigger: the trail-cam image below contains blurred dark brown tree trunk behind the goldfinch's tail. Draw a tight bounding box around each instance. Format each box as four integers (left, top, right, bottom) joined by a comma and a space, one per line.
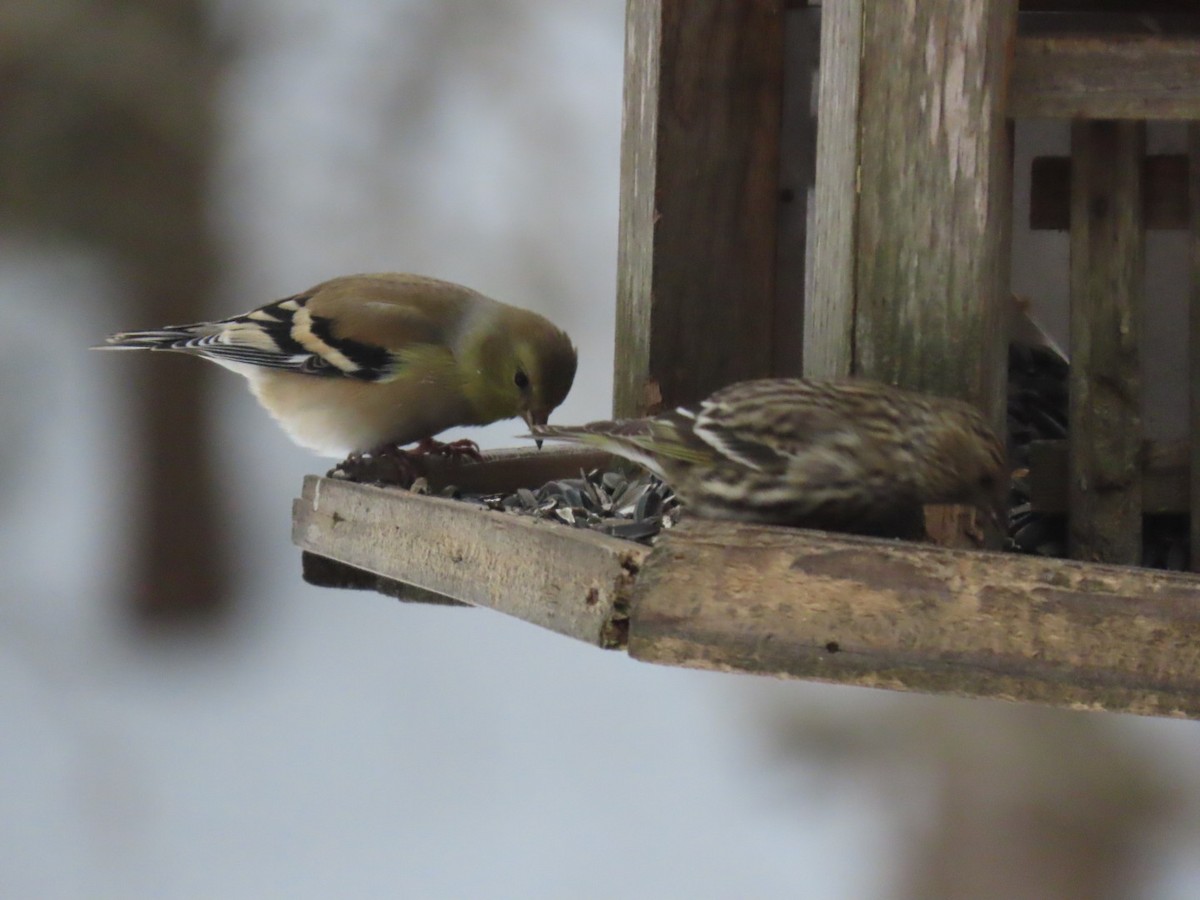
0, 0, 226, 625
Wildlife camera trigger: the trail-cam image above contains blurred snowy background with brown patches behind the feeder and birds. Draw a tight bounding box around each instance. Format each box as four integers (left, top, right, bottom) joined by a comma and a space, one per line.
7, 0, 1200, 899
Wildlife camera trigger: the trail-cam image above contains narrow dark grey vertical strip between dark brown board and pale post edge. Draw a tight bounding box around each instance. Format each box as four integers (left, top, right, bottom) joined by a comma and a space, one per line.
770, 7, 821, 378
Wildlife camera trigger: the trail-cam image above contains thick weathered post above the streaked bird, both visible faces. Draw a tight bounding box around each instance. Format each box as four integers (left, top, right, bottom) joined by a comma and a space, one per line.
805, 0, 1016, 410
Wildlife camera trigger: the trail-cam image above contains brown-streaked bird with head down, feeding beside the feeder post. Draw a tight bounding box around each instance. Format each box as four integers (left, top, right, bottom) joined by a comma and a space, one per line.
530, 378, 1004, 533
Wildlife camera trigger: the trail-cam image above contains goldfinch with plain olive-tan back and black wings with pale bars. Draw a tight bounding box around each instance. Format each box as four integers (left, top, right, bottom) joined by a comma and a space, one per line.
101, 274, 576, 456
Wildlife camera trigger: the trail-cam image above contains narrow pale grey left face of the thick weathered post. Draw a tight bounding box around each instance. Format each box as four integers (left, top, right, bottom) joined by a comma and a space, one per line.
804, 0, 863, 378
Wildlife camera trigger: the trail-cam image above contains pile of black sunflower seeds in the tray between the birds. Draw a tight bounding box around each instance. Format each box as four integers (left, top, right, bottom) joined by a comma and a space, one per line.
413, 469, 683, 544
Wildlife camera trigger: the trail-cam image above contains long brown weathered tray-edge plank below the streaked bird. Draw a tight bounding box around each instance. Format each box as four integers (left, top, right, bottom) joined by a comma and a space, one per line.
629, 521, 1200, 718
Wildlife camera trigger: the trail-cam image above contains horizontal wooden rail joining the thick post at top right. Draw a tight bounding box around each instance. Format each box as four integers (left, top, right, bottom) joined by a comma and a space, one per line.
1010, 35, 1200, 119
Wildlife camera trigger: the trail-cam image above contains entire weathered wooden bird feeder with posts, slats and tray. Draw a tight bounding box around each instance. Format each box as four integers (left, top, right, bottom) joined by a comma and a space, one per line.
294, 0, 1200, 718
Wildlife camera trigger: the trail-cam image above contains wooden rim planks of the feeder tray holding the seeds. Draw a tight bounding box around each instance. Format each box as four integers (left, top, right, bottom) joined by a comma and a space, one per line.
293, 450, 1200, 718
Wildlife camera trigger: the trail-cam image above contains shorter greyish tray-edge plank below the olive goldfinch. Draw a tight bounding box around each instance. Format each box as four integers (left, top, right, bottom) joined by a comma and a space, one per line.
292, 476, 648, 647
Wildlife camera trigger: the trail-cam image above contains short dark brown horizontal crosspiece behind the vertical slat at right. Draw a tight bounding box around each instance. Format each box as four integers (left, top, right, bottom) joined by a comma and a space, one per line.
1030, 154, 1189, 232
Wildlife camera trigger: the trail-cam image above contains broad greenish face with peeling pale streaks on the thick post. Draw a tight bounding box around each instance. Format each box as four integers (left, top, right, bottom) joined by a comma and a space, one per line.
853, 0, 1016, 428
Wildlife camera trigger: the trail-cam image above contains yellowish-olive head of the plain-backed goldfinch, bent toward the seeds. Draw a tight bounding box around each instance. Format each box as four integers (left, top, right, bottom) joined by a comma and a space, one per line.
466, 307, 577, 439
